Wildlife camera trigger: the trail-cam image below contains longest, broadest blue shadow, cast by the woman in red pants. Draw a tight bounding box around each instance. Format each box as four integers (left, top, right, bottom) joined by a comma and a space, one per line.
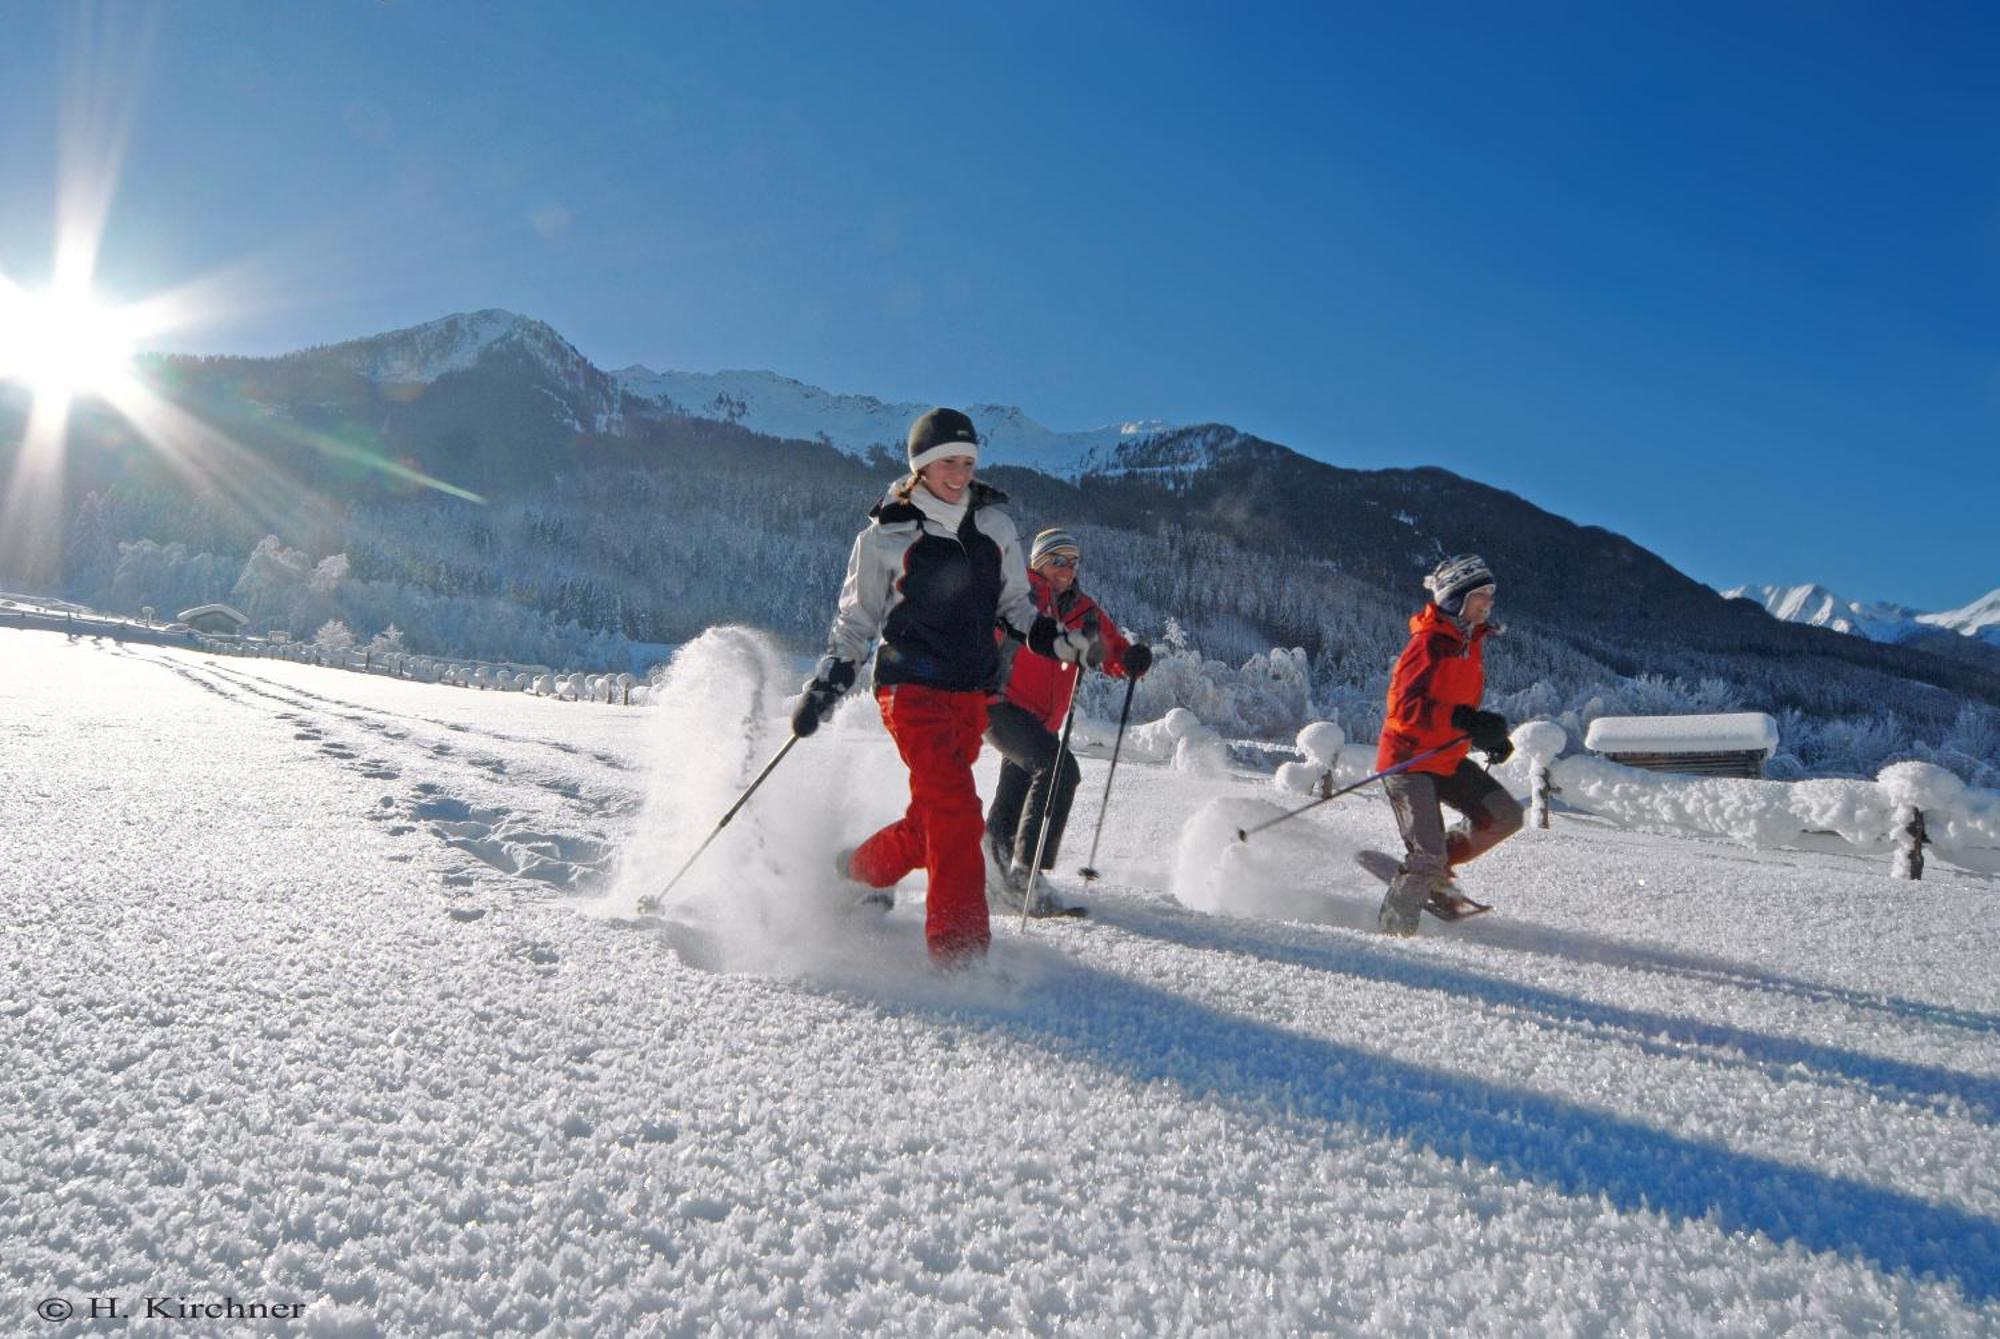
912, 943, 2000, 1303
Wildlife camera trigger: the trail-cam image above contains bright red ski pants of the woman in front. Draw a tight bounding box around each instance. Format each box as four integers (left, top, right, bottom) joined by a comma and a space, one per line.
848, 683, 992, 961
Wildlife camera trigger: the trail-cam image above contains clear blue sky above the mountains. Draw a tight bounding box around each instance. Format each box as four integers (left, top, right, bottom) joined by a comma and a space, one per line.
0, 0, 2000, 610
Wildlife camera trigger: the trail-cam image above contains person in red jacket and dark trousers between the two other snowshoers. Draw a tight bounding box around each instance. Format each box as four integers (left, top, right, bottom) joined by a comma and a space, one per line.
986, 530, 1152, 915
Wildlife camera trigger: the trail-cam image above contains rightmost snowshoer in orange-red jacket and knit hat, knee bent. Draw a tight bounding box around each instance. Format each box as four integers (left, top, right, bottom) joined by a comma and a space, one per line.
1376, 554, 1520, 935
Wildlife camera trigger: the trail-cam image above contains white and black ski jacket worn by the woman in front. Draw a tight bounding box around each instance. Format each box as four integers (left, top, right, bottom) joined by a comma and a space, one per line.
826, 480, 1056, 693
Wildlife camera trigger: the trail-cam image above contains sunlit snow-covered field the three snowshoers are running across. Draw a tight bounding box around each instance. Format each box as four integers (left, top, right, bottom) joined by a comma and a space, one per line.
0, 630, 2000, 1335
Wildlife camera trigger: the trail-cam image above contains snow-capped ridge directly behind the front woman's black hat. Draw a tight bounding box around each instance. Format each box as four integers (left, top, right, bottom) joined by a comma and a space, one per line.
612, 366, 1170, 476
